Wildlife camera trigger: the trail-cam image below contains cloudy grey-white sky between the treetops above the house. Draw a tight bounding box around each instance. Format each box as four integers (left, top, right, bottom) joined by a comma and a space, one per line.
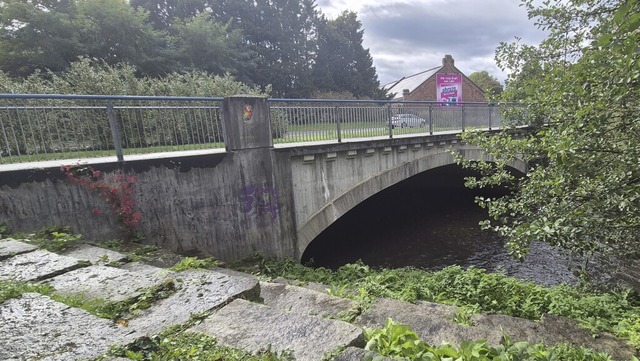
316, 0, 544, 85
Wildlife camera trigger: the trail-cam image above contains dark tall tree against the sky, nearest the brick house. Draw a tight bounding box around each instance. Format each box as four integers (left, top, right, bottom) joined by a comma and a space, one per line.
313, 11, 385, 99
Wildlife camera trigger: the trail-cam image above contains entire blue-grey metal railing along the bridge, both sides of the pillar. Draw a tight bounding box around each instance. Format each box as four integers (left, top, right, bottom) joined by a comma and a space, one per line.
0, 94, 520, 164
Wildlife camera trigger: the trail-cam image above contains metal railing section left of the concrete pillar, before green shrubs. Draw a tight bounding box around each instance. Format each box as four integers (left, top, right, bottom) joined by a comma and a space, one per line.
0, 94, 224, 163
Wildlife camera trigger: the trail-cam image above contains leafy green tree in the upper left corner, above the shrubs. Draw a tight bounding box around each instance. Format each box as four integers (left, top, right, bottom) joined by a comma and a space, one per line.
0, 0, 170, 77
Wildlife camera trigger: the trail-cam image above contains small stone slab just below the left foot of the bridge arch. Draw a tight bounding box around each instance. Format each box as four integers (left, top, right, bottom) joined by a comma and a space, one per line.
260, 282, 357, 318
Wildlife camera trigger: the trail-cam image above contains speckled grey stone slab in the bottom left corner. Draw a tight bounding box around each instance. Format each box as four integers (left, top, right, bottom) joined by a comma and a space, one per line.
0, 293, 130, 361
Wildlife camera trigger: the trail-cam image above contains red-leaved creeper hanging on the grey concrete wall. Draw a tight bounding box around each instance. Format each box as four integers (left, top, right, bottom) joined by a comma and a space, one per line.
60, 165, 142, 238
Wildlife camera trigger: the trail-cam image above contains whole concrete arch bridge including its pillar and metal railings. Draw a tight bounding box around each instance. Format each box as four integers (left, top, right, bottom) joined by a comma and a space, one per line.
0, 96, 526, 260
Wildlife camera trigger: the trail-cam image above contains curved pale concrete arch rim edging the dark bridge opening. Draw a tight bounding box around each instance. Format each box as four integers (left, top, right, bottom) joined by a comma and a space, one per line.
297, 144, 527, 259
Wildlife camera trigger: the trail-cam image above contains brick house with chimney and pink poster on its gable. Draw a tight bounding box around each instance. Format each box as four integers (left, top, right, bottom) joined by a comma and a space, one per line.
383, 55, 487, 102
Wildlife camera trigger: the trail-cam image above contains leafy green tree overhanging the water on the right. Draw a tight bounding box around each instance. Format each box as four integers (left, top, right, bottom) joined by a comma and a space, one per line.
462, 0, 640, 258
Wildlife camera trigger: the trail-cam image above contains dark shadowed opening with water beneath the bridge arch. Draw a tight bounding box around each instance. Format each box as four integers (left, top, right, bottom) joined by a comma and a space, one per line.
301, 165, 505, 269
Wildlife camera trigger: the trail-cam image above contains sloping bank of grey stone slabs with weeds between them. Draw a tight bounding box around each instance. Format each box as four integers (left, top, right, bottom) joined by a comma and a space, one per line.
0, 240, 634, 360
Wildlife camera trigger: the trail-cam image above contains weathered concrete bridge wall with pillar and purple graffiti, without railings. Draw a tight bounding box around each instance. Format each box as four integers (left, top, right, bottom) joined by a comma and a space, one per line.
0, 97, 525, 260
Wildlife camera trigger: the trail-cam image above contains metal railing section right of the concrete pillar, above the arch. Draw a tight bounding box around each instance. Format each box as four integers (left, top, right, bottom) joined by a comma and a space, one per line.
270, 99, 512, 144
